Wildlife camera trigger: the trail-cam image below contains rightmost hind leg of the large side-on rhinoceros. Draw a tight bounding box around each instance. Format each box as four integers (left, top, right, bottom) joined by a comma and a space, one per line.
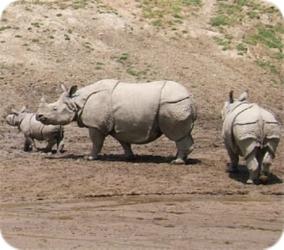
171, 135, 193, 164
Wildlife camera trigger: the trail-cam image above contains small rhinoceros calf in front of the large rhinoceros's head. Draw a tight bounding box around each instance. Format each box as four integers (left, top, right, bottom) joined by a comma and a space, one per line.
6, 107, 64, 152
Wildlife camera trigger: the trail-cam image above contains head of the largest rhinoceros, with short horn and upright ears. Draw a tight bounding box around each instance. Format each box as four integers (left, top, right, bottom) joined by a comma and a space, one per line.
36, 84, 77, 125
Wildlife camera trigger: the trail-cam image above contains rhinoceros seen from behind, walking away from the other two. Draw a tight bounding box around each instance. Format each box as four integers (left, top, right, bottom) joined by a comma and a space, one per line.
222, 91, 280, 184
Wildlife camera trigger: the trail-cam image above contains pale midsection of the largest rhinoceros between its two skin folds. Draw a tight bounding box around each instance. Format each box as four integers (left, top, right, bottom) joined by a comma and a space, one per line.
112, 81, 165, 144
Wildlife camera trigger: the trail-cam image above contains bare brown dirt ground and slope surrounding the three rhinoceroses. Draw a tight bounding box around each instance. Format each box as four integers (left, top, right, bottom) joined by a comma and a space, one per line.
0, 1, 284, 249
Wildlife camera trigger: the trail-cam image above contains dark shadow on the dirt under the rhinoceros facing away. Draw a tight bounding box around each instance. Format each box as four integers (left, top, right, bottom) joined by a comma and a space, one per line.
229, 165, 283, 185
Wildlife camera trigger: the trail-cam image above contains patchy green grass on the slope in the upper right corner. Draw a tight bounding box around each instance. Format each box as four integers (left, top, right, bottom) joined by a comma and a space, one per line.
210, 0, 284, 78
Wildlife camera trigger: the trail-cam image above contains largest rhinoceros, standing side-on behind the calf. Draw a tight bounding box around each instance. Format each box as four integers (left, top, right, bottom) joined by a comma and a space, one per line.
37, 79, 196, 164
